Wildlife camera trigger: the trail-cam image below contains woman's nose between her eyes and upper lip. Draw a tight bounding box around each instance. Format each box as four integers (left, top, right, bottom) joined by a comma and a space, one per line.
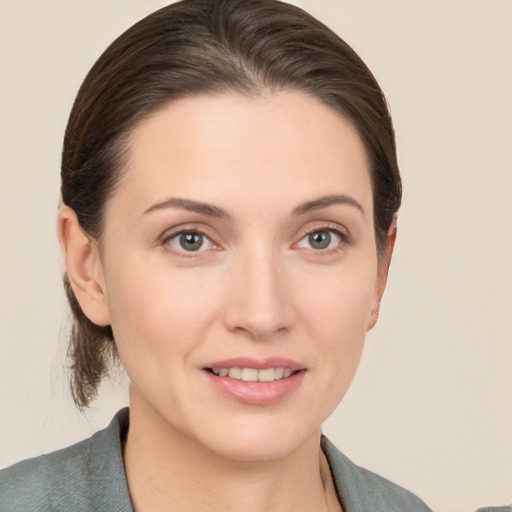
224, 244, 296, 340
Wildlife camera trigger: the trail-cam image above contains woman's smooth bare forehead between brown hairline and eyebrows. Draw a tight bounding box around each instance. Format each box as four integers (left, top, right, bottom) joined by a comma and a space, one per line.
120, 91, 371, 216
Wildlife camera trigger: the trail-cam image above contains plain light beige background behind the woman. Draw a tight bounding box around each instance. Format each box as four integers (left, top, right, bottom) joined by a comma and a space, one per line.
0, 0, 512, 512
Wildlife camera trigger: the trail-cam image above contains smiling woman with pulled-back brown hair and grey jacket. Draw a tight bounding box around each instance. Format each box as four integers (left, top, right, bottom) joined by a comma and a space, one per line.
0, 0, 428, 512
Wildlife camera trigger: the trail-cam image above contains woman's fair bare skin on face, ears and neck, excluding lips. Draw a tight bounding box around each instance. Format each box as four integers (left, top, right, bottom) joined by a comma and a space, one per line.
59, 92, 395, 512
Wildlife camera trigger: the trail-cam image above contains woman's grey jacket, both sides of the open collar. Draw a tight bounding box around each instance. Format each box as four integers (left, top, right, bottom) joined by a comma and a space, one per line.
0, 409, 430, 512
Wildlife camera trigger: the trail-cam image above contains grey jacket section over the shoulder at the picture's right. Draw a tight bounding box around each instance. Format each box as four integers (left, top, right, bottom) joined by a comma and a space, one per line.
322, 436, 430, 512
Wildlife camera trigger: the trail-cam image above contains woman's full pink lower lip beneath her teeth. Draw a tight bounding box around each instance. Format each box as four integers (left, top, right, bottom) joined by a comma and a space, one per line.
204, 370, 306, 405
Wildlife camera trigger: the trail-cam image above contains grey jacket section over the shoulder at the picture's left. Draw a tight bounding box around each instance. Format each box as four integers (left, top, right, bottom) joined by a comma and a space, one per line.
0, 409, 131, 512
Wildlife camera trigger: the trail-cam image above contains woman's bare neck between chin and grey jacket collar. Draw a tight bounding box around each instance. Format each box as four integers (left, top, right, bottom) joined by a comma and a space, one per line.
124, 392, 340, 512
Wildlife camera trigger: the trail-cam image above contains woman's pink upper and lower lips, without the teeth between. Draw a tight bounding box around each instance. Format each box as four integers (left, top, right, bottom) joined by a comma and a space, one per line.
204, 358, 306, 406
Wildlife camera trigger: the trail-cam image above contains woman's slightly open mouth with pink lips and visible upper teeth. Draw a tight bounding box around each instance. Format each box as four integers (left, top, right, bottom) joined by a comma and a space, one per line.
204, 358, 307, 405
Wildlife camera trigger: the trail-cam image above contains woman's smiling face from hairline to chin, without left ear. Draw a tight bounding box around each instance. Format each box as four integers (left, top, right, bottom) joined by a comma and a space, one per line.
96, 92, 388, 459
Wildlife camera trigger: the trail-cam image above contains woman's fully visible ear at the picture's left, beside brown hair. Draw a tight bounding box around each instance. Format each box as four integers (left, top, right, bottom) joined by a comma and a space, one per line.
57, 205, 110, 326
